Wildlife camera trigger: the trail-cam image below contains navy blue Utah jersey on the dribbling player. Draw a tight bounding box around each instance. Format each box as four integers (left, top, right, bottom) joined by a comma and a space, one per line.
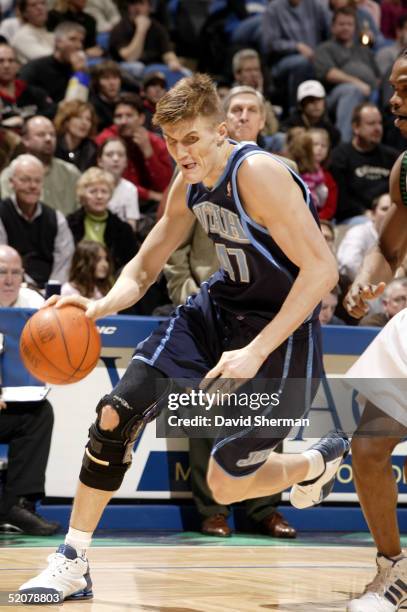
187, 142, 319, 318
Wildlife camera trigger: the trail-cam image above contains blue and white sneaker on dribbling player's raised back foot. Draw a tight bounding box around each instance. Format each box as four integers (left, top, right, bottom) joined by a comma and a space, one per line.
290, 431, 350, 509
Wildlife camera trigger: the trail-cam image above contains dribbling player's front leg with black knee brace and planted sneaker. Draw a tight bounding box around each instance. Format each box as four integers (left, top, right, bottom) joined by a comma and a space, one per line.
20, 361, 170, 599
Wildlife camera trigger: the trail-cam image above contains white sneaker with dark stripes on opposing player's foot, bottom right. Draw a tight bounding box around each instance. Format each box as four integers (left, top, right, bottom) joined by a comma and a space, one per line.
346, 555, 407, 612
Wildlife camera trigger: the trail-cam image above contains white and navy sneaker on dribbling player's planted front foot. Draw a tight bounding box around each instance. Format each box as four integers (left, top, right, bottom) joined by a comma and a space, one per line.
18, 544, 93, 604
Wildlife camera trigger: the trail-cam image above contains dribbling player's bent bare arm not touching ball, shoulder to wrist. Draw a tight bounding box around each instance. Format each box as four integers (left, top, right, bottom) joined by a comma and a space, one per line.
238, 155, 338, 358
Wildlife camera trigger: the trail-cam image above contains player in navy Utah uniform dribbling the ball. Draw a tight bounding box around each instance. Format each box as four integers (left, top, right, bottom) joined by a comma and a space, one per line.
21, 75, 348, 599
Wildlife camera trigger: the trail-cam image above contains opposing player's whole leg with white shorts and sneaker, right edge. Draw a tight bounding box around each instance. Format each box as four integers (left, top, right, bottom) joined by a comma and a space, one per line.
346, 309, 407, 612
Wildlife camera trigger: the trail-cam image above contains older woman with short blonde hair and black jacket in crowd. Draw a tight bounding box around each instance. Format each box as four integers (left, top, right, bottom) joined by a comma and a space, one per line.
67, 168, 137, 273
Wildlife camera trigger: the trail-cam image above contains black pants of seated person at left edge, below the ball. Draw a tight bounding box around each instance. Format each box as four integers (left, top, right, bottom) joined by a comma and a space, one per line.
0, 400, 54, 515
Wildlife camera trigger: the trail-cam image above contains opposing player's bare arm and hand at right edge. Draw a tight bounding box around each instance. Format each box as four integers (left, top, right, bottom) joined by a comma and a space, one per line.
344, 155, 407, 318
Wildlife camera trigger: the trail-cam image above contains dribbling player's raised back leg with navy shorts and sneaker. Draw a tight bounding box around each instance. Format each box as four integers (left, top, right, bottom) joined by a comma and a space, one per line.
208, 322, 349, 507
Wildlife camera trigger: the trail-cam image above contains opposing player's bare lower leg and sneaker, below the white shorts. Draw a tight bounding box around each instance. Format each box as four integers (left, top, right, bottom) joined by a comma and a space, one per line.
348, 402, 407, 612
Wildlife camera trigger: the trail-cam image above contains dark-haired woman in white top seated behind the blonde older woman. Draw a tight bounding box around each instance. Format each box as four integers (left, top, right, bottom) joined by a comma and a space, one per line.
98, 137, 140, 231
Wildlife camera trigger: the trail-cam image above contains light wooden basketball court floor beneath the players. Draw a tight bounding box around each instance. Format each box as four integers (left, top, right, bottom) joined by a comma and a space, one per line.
0, 536, 375, 612
